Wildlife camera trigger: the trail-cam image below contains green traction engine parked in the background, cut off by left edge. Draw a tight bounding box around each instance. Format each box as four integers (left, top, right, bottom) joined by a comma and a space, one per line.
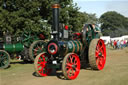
0, 31, 45, 69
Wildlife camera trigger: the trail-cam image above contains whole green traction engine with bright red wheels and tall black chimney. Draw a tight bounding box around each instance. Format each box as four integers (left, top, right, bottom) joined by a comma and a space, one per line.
34, 4, 106, 80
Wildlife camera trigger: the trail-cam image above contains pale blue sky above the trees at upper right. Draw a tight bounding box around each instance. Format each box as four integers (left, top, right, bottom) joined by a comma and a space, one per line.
73, 0, 128, 18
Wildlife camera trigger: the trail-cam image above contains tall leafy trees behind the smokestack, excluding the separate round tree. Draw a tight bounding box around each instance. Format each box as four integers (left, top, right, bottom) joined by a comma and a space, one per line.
0, 0, 96, 34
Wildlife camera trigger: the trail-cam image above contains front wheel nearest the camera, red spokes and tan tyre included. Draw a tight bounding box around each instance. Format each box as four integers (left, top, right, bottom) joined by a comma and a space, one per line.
62, 53, 80, 80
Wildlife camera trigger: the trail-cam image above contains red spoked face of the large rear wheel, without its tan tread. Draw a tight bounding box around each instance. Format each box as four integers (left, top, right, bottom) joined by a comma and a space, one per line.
95, 39, 106, 70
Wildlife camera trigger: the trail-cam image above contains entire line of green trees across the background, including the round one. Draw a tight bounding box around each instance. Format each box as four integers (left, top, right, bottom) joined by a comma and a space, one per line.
0, 0, 128, 36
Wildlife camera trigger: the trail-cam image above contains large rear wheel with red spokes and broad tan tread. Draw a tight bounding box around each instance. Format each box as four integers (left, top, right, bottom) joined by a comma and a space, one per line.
89, 39, 106, 70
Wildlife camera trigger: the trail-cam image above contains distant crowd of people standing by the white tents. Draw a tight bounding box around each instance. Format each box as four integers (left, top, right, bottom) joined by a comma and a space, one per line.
110, 40, 128, 49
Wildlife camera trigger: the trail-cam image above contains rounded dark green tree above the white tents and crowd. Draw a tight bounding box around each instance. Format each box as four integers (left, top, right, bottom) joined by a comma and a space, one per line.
100, 11, 128, 37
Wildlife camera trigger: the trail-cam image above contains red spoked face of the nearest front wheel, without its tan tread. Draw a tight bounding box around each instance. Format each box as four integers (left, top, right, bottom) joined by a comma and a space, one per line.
66, 54, 80, 79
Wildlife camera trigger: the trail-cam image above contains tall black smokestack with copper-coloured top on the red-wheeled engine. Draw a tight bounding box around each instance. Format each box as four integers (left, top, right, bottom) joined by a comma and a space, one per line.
52, 4, 60, 40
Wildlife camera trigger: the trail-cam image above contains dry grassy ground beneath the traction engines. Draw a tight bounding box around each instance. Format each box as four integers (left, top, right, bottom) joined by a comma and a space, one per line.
0, 48, 128, 85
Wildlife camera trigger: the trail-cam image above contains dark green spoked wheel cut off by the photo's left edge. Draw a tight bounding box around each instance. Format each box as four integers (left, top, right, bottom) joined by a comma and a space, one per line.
0, 50, 10, 69
